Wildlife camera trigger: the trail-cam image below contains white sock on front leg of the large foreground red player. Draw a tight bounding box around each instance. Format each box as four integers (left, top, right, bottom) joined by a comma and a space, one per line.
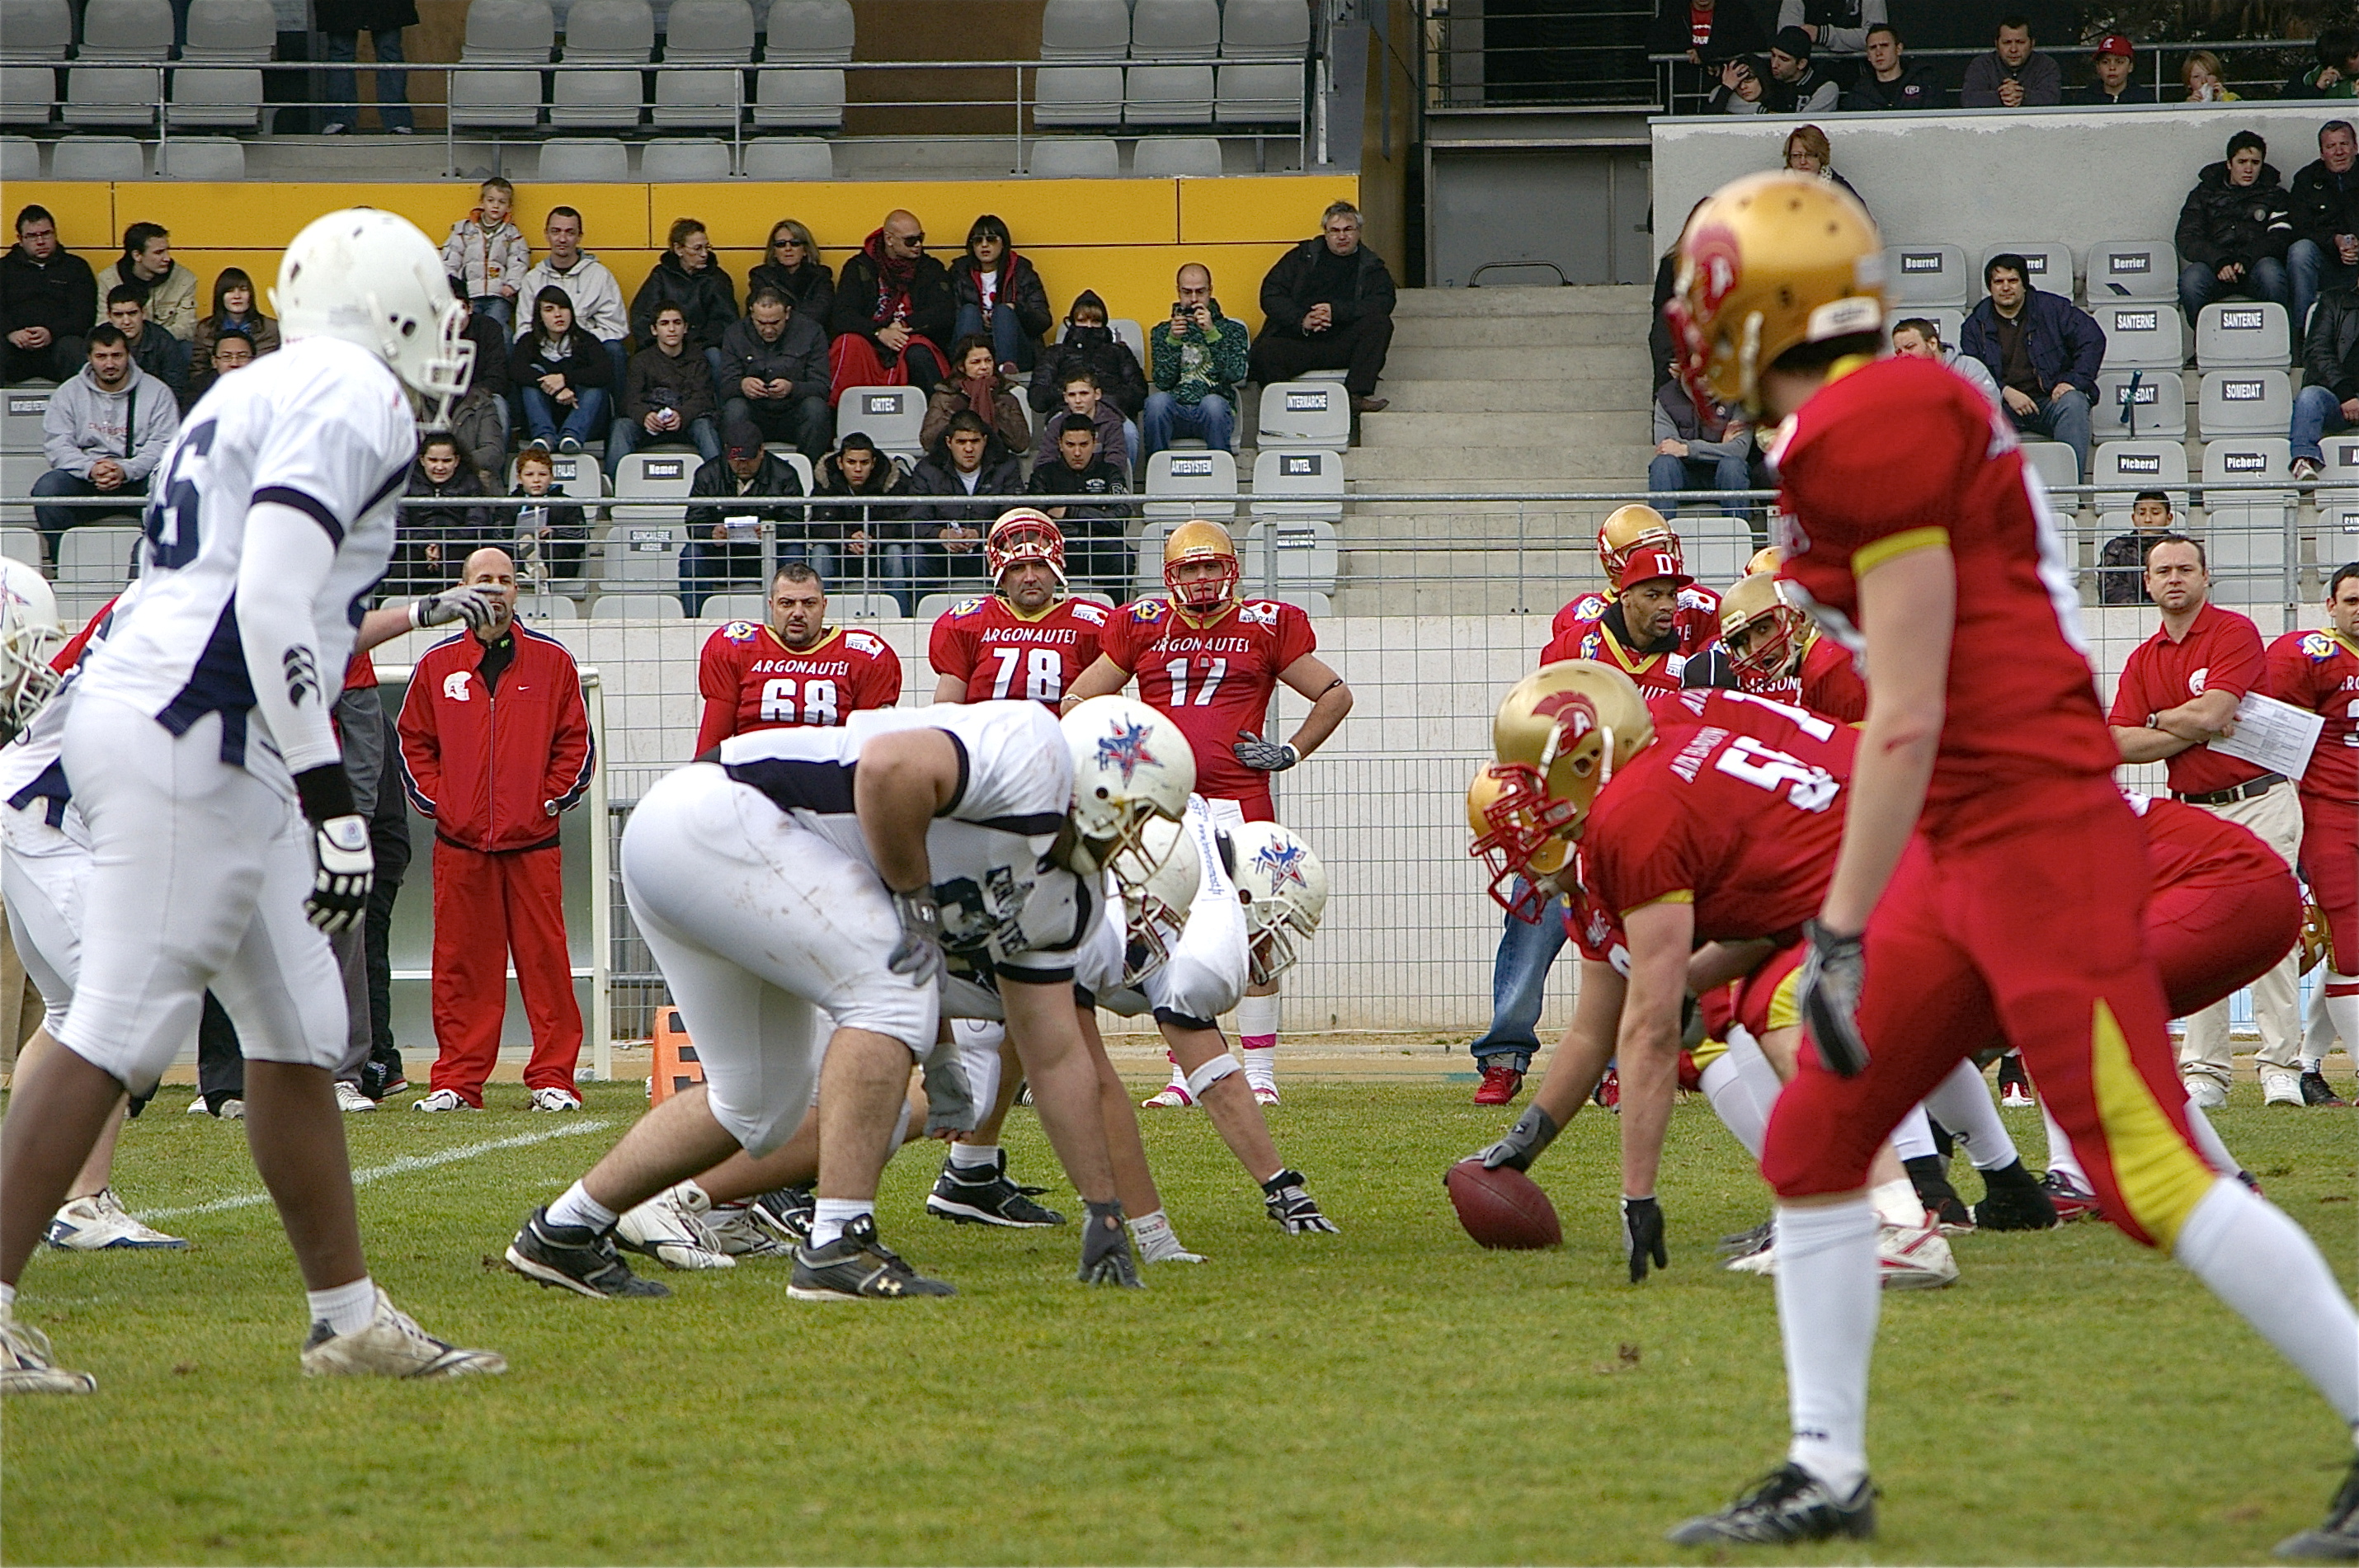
1777, 1198, 1882, 1497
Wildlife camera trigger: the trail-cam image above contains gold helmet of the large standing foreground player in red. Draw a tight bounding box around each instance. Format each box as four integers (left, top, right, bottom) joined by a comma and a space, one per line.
1663, 170, 1890, 412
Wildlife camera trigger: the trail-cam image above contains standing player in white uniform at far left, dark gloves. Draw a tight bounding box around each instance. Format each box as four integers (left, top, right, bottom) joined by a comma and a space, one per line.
0, 210, 507, 1393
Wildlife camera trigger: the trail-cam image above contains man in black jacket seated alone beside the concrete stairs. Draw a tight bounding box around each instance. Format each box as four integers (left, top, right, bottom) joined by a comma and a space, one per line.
1250, 200, 1391, 412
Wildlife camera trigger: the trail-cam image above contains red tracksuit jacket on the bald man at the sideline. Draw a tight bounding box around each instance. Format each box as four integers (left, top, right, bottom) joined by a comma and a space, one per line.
401, 623, 597, 854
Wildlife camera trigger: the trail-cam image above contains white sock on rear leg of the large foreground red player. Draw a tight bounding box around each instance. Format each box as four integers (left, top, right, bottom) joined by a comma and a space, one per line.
2173, 1179, 2359, 1426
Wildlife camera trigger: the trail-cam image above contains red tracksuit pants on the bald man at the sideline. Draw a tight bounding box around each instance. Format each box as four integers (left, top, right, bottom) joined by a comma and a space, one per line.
431, 837, 582, 1106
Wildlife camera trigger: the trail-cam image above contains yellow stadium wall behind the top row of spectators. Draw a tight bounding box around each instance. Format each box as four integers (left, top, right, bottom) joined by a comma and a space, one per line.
0, 175, 1358, 330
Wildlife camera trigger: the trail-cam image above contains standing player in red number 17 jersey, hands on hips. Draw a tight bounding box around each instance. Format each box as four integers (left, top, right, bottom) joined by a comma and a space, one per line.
1066, 519, 1352, 1106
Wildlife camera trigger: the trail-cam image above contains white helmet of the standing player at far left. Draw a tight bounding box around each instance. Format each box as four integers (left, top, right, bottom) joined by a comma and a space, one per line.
271, 208, 474, 426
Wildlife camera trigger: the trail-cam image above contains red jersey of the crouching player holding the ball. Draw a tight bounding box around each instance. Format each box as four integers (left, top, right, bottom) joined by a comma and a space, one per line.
1580, 686, 1859, 941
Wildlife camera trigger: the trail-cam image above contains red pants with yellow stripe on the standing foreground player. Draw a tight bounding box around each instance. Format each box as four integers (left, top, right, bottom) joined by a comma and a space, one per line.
1762, 778, 2215, 1245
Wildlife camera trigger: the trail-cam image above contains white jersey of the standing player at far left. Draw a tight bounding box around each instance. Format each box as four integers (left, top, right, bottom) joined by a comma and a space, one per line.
80, 337, 417, 778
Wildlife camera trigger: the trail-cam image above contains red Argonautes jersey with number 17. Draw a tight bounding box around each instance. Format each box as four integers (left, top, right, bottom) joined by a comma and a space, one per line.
1104, 599, 1319, 821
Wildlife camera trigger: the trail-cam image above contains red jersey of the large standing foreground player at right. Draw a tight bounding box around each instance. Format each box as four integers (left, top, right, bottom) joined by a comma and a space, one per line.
1774, 359, 2121, 830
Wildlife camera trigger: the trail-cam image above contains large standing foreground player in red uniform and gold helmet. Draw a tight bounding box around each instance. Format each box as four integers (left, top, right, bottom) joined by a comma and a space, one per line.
1668, 175, 2359, 1559
